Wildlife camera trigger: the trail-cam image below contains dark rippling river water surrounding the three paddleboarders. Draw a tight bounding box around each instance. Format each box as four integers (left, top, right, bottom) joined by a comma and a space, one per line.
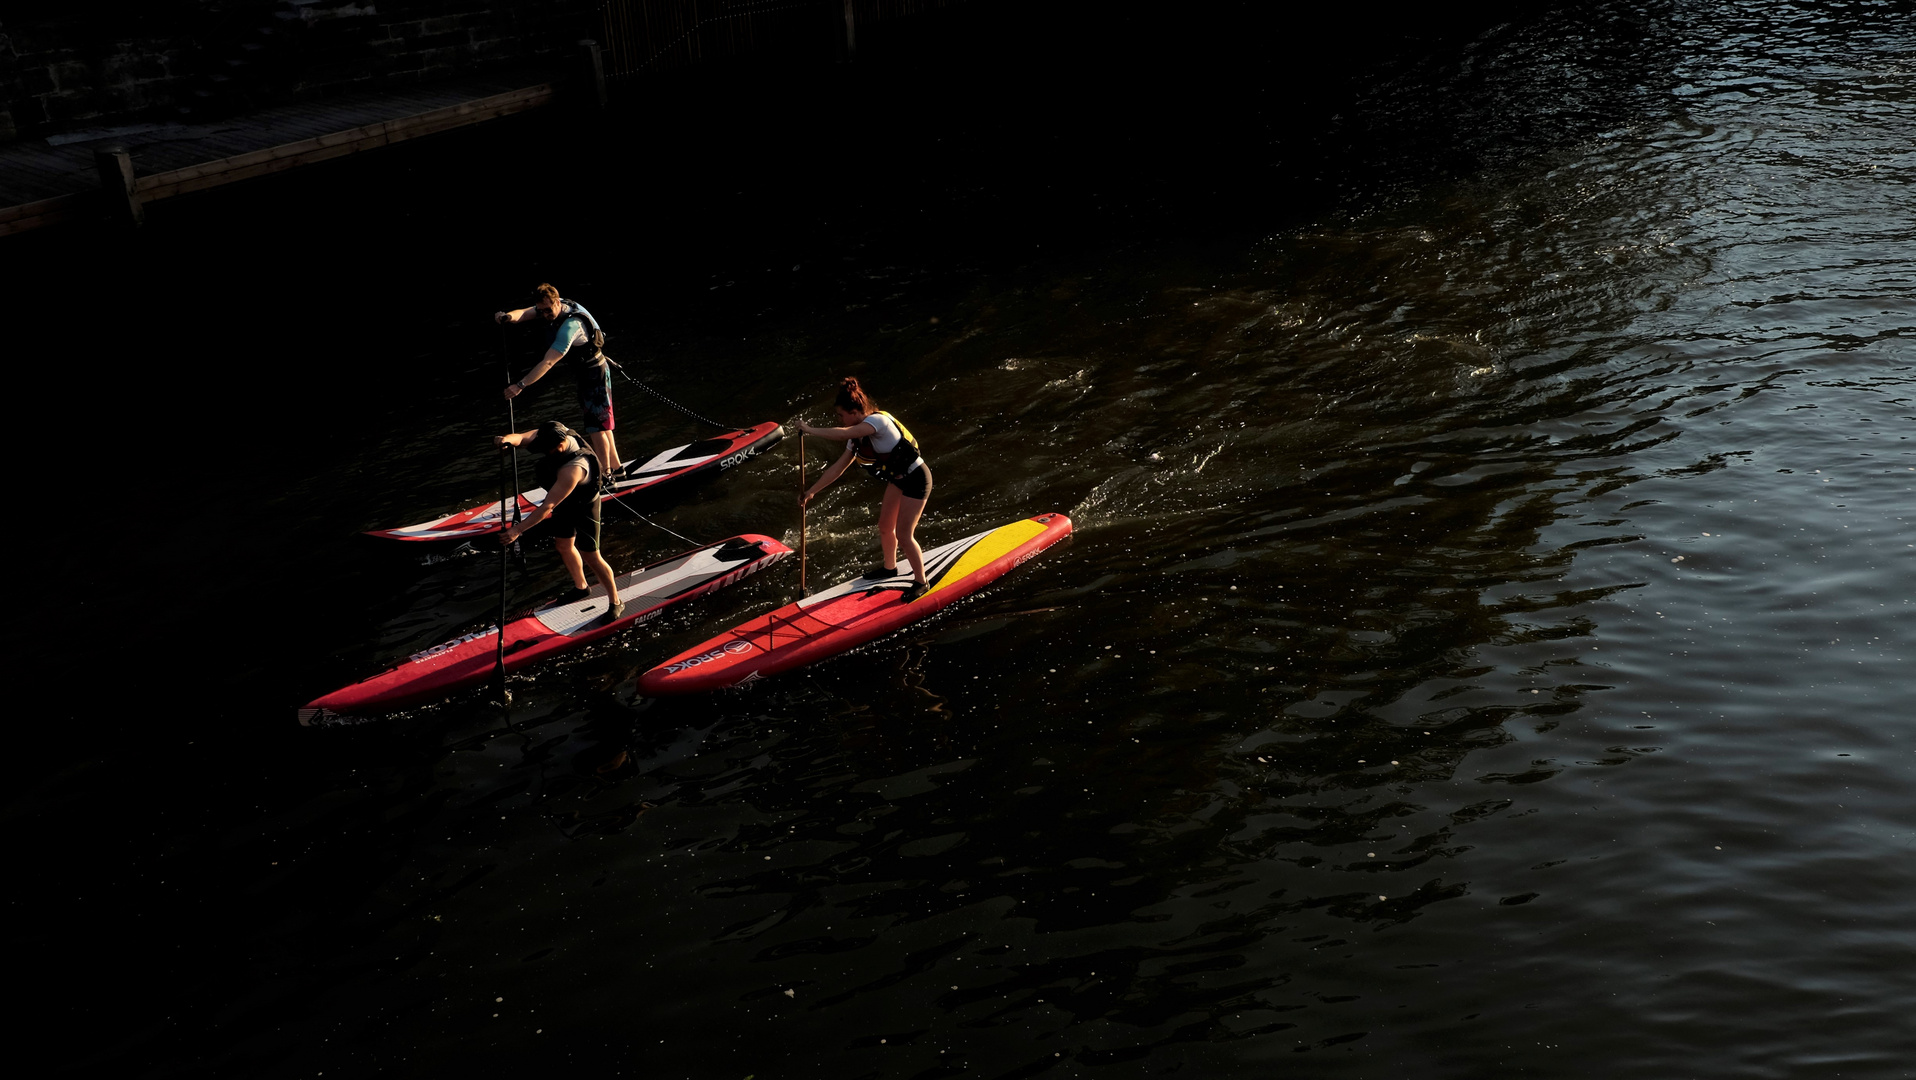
6, 0, 1916, 1078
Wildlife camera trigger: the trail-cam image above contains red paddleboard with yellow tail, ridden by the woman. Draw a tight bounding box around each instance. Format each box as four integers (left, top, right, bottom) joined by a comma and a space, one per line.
638, 513, 1071, 697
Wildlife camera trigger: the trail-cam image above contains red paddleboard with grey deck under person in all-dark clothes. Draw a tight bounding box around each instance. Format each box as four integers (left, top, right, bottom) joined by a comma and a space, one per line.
299, 534, 791, 726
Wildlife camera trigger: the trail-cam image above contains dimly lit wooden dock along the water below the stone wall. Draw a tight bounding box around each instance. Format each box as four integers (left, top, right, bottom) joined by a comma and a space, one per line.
0, 79, 558, 236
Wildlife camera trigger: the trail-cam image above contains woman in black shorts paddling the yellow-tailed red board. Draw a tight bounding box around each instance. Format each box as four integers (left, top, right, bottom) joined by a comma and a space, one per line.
797, 379, 931, 603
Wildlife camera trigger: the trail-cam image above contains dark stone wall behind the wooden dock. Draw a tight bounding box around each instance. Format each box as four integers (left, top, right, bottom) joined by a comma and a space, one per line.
0, 0, 598, 142
